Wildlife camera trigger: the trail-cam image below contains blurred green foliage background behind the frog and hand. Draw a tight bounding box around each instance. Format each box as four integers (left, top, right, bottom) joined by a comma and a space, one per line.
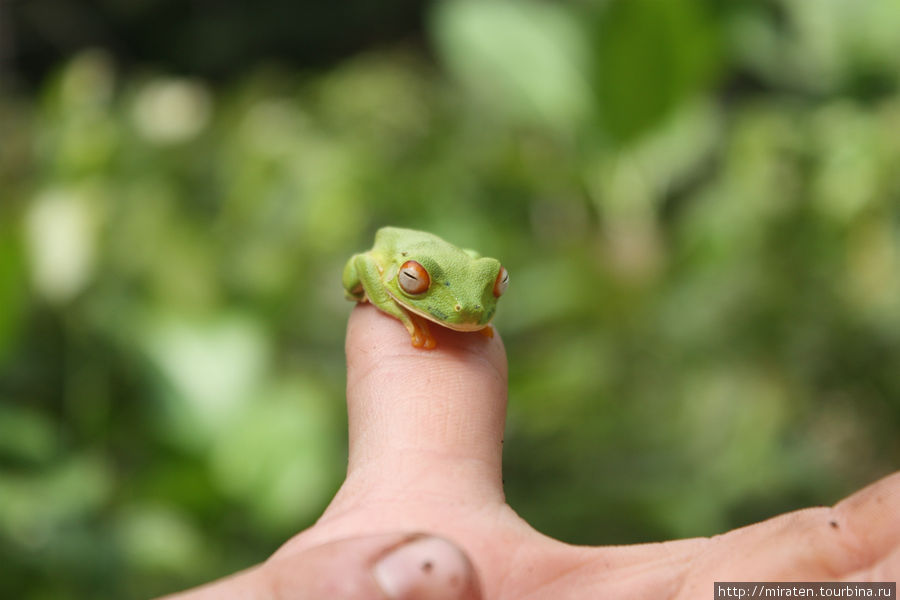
0, 0, 900, 599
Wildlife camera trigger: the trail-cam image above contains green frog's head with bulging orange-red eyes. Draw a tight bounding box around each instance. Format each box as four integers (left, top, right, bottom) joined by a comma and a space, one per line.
384, 249, 509, 331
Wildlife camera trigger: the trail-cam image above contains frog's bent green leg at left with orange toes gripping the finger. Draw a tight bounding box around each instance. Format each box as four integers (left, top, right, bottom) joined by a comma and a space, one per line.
343, 253, 437, 350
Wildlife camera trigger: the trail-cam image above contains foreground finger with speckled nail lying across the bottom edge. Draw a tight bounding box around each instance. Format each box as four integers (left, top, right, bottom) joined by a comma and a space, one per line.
169, 534, 481, 600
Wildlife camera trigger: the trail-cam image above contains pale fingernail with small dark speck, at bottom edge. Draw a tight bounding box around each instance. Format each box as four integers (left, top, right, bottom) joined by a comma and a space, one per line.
374, 536, 472, 600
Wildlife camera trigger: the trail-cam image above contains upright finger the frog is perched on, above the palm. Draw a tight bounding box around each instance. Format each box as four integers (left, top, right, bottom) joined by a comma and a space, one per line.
346, 305, 507, 498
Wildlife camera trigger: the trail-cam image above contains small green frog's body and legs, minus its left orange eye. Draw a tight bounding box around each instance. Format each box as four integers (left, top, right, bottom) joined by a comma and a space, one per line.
343, 227, 506, 348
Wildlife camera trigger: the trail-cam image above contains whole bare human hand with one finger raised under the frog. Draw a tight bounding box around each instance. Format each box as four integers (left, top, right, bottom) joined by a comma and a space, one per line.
165, 305, 900, 600
